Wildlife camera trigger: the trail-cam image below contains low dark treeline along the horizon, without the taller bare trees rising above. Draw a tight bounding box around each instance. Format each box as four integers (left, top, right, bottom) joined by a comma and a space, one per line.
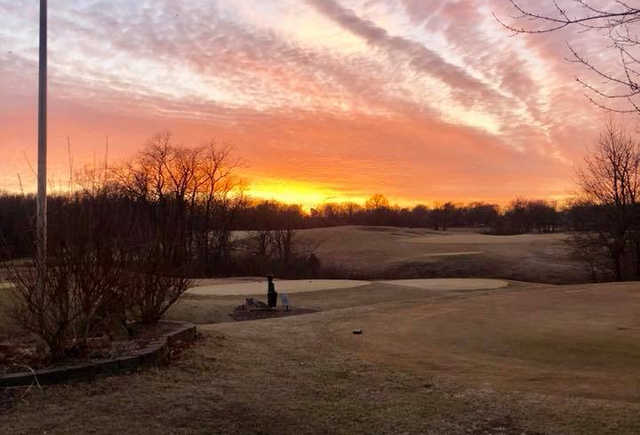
0, 190, 568, 261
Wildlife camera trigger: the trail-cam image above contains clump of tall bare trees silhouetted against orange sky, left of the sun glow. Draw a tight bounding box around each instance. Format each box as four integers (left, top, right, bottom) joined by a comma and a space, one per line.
112, 133, 244, 274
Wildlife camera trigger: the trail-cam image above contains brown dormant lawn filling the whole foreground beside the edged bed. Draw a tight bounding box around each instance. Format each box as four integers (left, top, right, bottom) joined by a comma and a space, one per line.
0, 283, 640, 434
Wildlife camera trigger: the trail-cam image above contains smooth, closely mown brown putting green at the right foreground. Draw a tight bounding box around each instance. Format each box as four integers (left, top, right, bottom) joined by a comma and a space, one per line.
340, 283, 640, 402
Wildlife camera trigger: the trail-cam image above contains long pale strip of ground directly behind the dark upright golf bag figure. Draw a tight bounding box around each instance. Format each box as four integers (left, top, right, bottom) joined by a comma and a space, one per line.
187, 279, 370, 296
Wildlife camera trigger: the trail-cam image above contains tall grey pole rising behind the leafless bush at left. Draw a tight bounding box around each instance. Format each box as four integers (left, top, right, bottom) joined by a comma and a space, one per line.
36, 0, 47, 291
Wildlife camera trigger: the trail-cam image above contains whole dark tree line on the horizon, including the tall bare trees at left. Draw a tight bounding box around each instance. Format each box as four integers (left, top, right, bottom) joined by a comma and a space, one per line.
0, 178, 564, 275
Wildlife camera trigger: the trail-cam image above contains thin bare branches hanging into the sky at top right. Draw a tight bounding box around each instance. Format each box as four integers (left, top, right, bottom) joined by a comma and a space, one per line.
494, 0, 640, 112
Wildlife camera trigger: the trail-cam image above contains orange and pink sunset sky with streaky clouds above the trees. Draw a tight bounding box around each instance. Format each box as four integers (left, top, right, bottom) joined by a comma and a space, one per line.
0, 0, 632, 206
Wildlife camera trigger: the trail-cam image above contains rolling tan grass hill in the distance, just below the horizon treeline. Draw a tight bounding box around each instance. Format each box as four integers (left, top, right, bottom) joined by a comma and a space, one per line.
297, 226, 589, 284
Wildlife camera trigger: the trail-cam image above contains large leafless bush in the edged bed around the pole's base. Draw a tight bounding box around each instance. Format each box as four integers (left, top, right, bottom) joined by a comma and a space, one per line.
8, 188, 190, 360
